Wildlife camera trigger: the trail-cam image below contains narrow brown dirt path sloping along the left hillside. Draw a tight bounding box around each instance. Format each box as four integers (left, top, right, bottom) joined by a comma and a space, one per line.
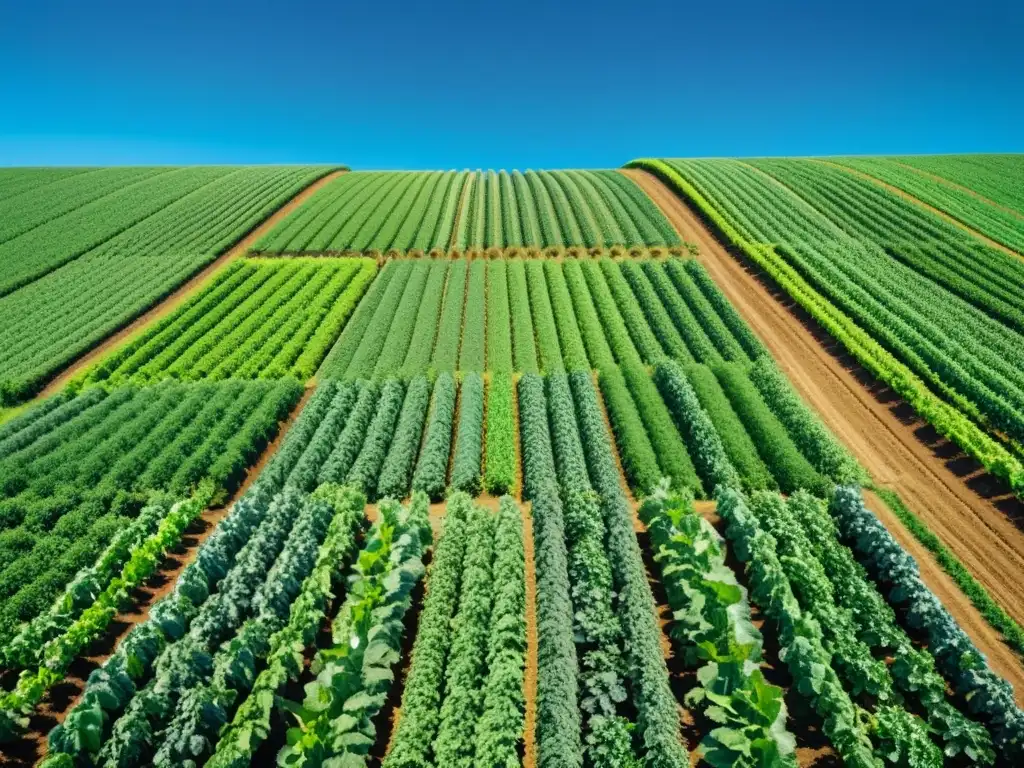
34, 170, 345, 400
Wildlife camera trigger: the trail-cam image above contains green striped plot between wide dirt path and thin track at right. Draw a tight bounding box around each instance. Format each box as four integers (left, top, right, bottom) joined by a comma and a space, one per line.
642, 161, 1024, 494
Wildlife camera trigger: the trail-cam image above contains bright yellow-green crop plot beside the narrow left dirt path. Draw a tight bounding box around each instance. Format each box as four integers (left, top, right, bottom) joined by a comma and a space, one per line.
84, 259, 376, 385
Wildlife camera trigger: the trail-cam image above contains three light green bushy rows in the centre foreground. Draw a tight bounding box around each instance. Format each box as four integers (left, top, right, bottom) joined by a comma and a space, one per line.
383, 493, 526, 768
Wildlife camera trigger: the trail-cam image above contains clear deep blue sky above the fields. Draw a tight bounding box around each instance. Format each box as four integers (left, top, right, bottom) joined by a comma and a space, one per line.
0, 0, 1024, 169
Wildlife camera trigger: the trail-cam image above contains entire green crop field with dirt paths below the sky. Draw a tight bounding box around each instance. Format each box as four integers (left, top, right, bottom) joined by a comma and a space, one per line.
0, 156, 1024, 768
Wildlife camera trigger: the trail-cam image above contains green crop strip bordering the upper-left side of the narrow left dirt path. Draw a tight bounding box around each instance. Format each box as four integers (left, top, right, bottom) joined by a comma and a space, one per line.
0, 167, 328, 404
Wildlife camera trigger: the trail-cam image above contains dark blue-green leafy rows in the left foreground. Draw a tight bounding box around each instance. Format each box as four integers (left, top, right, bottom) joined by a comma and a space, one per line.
39, 486, 365, 766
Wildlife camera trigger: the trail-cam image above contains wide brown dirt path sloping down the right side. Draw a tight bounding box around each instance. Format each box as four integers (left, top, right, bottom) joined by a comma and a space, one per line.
624, 165, 1024, 688
